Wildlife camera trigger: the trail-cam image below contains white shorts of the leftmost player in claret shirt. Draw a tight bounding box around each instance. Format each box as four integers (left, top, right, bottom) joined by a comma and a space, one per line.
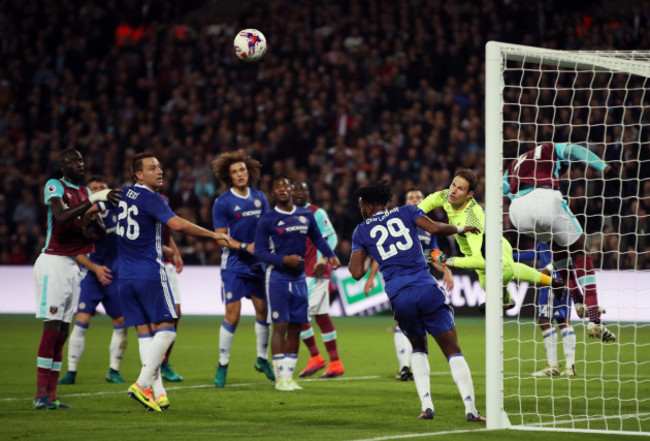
34, 253, 81, 323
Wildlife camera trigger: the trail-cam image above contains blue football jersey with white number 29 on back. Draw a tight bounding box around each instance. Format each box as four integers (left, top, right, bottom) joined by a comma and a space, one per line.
352, 205, 437, 298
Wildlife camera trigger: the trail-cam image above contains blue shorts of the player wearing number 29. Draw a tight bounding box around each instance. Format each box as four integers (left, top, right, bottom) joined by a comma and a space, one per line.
390, 285, 455, 336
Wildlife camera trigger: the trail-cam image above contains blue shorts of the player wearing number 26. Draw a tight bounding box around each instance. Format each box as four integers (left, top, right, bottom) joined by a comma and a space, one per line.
119, 279, 178, 326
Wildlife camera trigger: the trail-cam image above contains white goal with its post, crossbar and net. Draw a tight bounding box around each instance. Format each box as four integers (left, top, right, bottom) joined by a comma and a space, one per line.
485, 42, 650, 436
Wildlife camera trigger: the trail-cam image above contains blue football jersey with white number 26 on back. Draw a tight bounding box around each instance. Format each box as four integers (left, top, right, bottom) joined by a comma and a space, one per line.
116, 184, 175, 280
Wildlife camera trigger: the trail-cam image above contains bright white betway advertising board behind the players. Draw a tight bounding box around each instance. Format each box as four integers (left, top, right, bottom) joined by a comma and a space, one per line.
0, 266, 650, 322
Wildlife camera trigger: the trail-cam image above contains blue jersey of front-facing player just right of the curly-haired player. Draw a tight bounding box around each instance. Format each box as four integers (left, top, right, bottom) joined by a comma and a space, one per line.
255, 206, 334, 280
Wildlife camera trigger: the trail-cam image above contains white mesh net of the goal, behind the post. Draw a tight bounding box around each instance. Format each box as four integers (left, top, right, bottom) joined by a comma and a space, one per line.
498, 50, 650, 432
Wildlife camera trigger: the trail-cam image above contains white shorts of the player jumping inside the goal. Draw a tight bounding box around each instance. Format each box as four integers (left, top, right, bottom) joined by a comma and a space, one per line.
510, 188, 583, 246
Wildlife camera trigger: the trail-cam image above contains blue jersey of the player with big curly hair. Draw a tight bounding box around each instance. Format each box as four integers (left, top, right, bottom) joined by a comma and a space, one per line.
212, 187, 269, 277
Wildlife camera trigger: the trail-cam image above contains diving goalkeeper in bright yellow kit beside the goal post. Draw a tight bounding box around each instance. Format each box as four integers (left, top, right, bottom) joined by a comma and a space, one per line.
418, 169, 565, 309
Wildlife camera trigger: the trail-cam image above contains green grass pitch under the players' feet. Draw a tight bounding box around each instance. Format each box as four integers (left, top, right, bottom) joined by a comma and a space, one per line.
0, 315, 650, 441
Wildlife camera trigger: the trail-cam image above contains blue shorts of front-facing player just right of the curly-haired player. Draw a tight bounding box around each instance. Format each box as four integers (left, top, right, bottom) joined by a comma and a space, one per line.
266, 269, 309, 323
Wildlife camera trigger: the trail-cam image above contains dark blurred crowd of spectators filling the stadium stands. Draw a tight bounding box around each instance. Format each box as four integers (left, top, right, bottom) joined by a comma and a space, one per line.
0, 0, 650, 269
